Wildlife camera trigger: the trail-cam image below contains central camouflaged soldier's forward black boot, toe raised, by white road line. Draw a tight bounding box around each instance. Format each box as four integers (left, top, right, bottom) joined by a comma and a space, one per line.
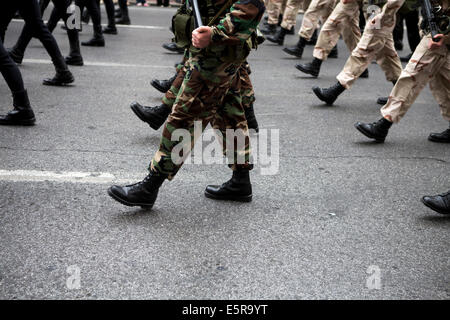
108, 171, 167, 210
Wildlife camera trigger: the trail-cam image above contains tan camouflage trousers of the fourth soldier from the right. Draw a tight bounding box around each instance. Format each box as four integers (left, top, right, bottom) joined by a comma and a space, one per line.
298, 0, 336, 41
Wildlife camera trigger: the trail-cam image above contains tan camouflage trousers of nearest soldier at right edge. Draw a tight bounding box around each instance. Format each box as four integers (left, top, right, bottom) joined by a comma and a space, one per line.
381, 35, 450, 123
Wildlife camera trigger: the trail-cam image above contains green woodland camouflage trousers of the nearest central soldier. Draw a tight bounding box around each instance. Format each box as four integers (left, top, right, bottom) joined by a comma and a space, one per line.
150, 55, 252, 180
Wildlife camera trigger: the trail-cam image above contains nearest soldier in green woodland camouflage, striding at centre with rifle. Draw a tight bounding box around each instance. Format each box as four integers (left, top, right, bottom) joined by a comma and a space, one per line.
108, 0, 265, 208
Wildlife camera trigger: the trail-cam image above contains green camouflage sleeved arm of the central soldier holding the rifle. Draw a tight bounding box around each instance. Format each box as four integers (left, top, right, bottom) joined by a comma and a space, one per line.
211, 0, 265, 45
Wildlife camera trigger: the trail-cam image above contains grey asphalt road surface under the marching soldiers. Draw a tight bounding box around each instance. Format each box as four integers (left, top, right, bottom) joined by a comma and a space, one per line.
0, 7, 450, 299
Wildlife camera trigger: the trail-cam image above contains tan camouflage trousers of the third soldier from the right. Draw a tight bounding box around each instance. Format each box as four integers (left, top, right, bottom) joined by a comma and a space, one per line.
313, 0, 361, 61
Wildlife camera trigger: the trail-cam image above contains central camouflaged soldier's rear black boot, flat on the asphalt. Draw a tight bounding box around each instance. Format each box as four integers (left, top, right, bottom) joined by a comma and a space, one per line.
205, 169, 252, 202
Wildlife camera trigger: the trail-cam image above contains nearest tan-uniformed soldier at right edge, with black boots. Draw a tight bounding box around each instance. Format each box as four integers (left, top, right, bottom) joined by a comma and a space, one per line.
355, 0, 450, 143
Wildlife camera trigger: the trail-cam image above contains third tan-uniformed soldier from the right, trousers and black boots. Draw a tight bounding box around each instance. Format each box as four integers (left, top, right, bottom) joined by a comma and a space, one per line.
295, 0, 369, 78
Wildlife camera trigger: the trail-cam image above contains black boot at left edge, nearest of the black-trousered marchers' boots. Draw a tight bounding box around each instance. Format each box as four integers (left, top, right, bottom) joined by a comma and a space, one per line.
0, 90, 36, 126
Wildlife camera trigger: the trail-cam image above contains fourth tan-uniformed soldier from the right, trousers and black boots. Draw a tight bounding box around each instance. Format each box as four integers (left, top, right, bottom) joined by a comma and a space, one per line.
283, 0, 337, 58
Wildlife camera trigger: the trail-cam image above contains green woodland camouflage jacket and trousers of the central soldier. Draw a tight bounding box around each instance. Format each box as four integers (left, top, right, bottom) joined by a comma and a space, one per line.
150, 0, 265, 180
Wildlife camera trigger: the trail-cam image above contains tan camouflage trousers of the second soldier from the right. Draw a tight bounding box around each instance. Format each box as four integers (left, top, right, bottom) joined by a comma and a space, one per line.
336, 0, 405, 89
